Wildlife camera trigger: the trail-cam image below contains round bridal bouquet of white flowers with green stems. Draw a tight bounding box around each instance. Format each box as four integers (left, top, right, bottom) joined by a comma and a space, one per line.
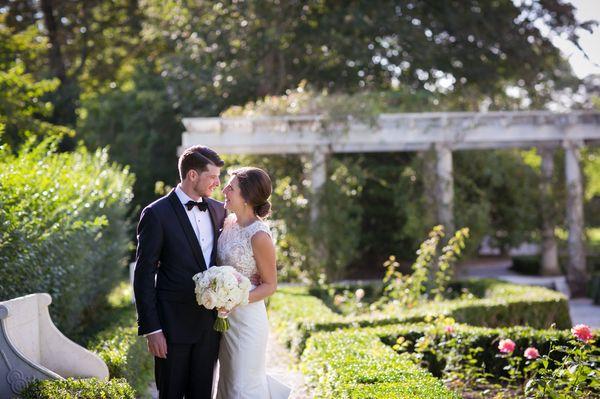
192, 266, 250, 332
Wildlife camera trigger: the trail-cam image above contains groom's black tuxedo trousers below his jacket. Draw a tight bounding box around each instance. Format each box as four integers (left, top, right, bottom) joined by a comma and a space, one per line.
154, 329, 221, 399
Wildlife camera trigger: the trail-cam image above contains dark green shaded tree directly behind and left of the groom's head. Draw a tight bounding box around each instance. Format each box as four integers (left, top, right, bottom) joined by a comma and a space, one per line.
77, 64, 183, 217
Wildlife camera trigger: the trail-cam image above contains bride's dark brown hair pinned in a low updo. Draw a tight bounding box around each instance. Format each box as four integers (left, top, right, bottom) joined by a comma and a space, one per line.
231, 166, 273, 218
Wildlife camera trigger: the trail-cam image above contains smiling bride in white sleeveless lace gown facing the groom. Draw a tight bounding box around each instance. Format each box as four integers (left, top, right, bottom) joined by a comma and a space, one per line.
217, 167, 290, 399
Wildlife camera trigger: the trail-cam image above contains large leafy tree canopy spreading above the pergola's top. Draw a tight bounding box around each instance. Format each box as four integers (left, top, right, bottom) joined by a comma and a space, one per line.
142, 0, 593, 115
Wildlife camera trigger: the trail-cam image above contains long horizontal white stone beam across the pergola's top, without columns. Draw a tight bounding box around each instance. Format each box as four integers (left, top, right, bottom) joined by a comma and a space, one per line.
182, 111, 600, 154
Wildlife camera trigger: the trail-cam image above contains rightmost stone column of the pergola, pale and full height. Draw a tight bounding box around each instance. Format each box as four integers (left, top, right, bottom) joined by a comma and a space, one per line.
563, 141, 588, 297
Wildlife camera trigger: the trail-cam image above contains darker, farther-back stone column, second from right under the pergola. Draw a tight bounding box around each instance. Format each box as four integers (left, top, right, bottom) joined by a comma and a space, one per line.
539, 147, 561, 275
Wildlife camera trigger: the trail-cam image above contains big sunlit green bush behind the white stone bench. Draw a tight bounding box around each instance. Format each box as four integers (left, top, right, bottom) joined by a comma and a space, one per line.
0, 140, 133, 334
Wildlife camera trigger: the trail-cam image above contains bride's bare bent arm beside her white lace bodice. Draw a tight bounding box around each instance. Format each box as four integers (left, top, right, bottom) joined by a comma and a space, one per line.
249, 231, 277, 303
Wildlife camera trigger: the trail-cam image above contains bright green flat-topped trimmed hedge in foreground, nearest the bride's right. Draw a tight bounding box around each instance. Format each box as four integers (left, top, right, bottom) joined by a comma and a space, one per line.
301, 331, 458, 399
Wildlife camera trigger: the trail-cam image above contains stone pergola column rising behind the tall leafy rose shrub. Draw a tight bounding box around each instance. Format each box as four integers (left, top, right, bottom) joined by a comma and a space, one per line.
435, 143, 454, 236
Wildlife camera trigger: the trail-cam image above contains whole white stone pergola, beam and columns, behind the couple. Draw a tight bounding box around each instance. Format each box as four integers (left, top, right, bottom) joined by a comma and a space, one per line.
181, 111, 600, 294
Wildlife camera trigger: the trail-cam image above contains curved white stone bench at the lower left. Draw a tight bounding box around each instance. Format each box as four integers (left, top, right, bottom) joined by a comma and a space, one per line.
0, 294, 108, 398
